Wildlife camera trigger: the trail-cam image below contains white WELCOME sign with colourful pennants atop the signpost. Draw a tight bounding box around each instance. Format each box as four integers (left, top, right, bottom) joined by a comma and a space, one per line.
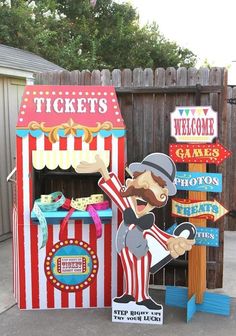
170, 106, 218, 143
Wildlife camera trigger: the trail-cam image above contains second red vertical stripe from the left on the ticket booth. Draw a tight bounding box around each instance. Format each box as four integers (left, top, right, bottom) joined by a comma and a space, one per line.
29, 135, 39, 308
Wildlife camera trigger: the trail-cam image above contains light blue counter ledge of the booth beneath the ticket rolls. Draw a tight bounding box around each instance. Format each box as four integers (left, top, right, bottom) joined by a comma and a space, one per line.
30, 208, 112, 224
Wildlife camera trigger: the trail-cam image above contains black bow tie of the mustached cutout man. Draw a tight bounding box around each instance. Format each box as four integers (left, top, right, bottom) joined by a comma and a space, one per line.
124, 208, 154, 231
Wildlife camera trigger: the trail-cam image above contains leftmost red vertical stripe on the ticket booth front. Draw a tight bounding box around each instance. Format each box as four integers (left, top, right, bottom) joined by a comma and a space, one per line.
16, 137, 26, 309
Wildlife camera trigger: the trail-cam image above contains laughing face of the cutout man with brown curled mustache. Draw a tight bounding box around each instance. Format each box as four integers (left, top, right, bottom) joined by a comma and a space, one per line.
121, 171, 168, 216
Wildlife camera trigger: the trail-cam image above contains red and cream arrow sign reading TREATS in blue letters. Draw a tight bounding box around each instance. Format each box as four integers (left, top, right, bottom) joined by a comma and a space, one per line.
172, 198, 228, 222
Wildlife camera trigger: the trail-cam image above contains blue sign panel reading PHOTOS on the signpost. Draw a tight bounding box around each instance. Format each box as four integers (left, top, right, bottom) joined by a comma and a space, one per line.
175, 171, 222, 192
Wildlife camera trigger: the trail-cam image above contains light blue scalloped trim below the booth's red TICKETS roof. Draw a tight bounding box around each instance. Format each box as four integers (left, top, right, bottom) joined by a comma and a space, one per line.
16, 129, 126, 138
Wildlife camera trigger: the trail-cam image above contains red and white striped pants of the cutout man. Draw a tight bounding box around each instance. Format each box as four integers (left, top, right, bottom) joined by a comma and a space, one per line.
119, 247, 152, 302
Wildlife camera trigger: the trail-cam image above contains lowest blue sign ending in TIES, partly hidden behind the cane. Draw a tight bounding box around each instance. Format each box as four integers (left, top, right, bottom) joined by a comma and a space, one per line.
166, 224, 219, 247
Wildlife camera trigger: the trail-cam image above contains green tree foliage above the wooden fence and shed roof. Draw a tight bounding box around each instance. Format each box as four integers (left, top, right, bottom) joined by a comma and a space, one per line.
0, 0, 196, 70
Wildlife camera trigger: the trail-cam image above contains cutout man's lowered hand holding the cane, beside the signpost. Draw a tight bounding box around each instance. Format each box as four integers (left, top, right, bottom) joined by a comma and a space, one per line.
167, 237, 195, 258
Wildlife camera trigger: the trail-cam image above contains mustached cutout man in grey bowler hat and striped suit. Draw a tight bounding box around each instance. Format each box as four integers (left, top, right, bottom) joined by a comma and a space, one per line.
76, 153, 194, 310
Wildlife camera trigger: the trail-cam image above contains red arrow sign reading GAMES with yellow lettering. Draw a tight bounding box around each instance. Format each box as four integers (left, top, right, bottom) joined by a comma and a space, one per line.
169, 143, 232, 165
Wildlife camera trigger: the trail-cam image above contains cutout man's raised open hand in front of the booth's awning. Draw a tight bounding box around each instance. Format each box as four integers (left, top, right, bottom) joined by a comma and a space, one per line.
75, 154, 110, 181
